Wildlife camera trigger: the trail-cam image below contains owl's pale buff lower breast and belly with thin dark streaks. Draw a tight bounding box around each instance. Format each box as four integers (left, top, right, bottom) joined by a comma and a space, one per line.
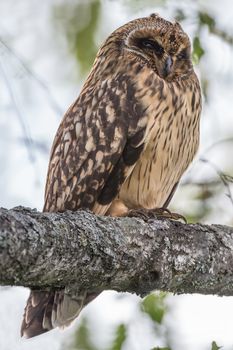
119, 86, 200, 209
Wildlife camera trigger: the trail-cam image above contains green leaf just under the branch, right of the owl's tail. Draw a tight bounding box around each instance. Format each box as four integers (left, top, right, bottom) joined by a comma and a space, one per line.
141, 292, 167, 324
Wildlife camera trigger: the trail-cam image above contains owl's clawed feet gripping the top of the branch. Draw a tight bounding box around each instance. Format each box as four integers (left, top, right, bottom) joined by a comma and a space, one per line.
127, 208, 187, 224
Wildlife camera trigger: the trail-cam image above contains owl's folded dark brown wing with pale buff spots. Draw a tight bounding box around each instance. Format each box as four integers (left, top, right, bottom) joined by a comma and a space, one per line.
44, 77, 146, 214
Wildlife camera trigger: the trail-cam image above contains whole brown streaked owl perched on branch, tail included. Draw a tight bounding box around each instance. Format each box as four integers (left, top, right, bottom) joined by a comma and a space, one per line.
21, 14, 201, 337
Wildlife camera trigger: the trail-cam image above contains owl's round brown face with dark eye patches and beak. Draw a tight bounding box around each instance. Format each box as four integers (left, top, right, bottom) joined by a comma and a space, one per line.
125, 16, 192, 80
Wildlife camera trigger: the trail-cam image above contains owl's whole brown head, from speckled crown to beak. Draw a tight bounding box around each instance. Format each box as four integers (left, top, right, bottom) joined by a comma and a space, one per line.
104, 14, 193, 81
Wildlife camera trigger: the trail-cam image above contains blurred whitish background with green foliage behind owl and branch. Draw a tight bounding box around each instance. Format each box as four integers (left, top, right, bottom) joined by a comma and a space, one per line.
0, 0, 233, 350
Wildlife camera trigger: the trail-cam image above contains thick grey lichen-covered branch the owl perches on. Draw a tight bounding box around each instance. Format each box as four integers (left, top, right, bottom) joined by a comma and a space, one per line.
0, 207, 233, 296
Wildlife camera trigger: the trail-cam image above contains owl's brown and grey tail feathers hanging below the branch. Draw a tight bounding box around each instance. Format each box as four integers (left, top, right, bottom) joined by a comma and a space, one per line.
21, 291, 94, 338
